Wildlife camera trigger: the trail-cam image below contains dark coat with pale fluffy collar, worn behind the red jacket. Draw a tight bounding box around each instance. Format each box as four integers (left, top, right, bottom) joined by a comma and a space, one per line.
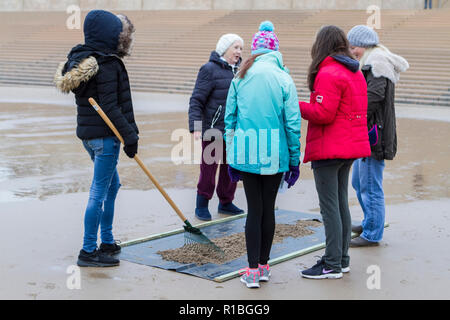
362, 66, 397, 160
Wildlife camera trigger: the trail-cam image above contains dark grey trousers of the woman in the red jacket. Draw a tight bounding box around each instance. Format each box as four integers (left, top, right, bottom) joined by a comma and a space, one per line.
314, 160, 353, 272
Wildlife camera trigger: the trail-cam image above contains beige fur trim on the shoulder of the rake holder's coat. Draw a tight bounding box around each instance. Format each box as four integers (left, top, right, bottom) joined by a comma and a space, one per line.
54, 56, 98, 93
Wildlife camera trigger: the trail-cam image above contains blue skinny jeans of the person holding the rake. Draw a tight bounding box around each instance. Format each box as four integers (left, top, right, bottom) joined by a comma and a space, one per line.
83, 137, 120, 252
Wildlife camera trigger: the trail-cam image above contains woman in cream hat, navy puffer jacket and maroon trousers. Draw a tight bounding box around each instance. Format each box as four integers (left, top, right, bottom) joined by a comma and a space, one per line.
189, 34, 244, 221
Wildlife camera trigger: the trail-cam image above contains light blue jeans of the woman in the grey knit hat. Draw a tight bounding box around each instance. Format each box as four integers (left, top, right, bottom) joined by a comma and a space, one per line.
352, 158, 385, 242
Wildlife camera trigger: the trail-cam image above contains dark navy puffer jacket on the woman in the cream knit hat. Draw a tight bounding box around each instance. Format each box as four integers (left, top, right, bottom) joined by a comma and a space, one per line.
189, 51, 240, 133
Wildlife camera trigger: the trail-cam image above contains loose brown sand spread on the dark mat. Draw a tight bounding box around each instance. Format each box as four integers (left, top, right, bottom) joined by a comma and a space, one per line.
157, 220, 321, 265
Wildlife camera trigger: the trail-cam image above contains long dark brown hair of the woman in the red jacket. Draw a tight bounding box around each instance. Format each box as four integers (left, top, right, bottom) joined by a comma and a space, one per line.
308, 26, 354, 91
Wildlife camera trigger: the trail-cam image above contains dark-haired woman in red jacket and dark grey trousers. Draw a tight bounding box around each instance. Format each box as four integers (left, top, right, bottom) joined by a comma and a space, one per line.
300, 26, 370, 279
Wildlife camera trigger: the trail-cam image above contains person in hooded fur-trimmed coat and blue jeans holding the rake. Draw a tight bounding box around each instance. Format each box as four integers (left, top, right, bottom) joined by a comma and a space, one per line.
55, 10, 139, 267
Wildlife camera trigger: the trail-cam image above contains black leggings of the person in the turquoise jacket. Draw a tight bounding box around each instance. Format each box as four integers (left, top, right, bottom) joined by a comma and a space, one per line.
241, 172, 283, 268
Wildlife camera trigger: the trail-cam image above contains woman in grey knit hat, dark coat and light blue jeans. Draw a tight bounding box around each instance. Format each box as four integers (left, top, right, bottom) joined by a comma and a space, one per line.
347, 25, 409, 247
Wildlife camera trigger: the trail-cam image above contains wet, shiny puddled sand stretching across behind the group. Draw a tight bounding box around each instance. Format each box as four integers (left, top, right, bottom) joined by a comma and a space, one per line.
0, 104, 450, 203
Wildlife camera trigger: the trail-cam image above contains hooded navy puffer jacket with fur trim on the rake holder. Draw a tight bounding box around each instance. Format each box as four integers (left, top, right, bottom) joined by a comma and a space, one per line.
55, 10, 139, 145
